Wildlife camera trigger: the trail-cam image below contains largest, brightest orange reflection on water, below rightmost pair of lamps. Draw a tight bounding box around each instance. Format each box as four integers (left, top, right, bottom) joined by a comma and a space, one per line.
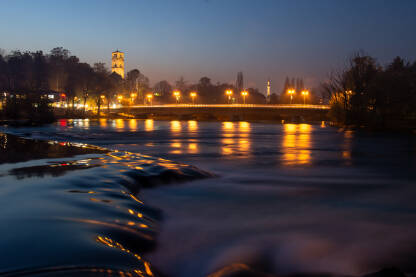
282, 124, 312, 165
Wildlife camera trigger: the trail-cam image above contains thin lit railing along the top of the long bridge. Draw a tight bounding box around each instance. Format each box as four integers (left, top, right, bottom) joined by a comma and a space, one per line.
125, 104, 330, 110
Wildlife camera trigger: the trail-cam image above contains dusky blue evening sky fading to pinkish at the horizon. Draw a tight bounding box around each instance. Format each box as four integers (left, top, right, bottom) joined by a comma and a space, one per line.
0, 0, 416, 92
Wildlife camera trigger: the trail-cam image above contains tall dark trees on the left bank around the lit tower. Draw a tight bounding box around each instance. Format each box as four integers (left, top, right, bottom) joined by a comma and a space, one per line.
0, 47, 149, 120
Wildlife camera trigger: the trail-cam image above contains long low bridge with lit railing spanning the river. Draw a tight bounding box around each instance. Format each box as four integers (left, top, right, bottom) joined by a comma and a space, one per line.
111, 104, 330, 121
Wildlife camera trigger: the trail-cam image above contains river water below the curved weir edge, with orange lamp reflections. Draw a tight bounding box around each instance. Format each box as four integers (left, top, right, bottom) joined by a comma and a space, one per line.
3, 119, 416, 277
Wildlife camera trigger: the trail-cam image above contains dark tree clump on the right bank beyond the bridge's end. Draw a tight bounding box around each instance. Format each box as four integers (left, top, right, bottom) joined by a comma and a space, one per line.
323, 53, 416, 129
